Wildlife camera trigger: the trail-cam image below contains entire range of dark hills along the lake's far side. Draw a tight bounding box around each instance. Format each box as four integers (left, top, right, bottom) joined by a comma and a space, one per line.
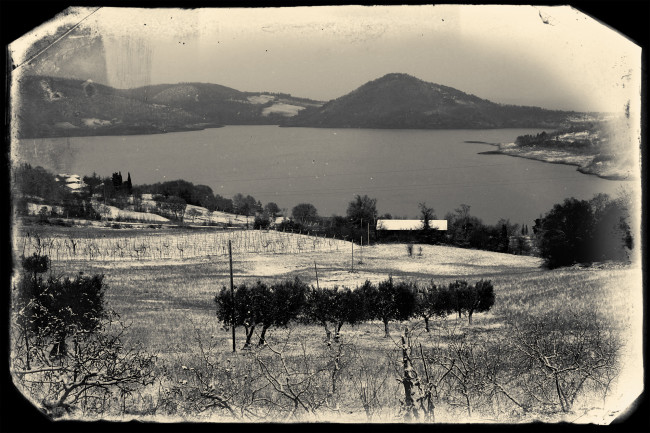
15, 73, 576, 138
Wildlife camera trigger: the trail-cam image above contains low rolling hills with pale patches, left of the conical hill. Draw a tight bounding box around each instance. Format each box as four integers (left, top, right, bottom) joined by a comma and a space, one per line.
15, 75, 321, 138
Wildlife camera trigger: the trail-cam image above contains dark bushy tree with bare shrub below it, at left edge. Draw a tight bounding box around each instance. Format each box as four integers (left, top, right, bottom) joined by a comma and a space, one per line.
11, 254, 155, 416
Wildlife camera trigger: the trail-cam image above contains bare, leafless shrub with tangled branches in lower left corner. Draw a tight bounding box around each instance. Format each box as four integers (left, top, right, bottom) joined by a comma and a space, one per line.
11, 316, 155, 418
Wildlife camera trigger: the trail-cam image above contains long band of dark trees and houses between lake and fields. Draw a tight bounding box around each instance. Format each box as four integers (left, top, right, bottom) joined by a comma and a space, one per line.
12, 164, 634, 267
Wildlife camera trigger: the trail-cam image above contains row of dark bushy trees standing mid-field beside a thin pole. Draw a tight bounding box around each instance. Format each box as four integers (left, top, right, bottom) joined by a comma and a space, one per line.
214, 277, 495, 347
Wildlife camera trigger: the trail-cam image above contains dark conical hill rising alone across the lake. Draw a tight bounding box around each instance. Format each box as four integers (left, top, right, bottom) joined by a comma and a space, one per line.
285, 73, 571, 129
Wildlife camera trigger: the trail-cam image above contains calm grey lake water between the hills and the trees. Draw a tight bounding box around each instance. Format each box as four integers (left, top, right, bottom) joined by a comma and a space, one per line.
15, 126, 631, 226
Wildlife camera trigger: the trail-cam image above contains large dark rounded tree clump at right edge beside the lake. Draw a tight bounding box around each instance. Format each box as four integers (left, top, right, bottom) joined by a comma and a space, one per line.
533, 194, 633, 268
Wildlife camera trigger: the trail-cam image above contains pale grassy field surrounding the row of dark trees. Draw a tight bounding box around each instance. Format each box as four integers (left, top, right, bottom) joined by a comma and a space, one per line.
12, 226, 642, 423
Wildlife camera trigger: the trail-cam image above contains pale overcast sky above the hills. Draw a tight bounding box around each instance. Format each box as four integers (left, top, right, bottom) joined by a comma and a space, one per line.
13, 5, 641, 112
